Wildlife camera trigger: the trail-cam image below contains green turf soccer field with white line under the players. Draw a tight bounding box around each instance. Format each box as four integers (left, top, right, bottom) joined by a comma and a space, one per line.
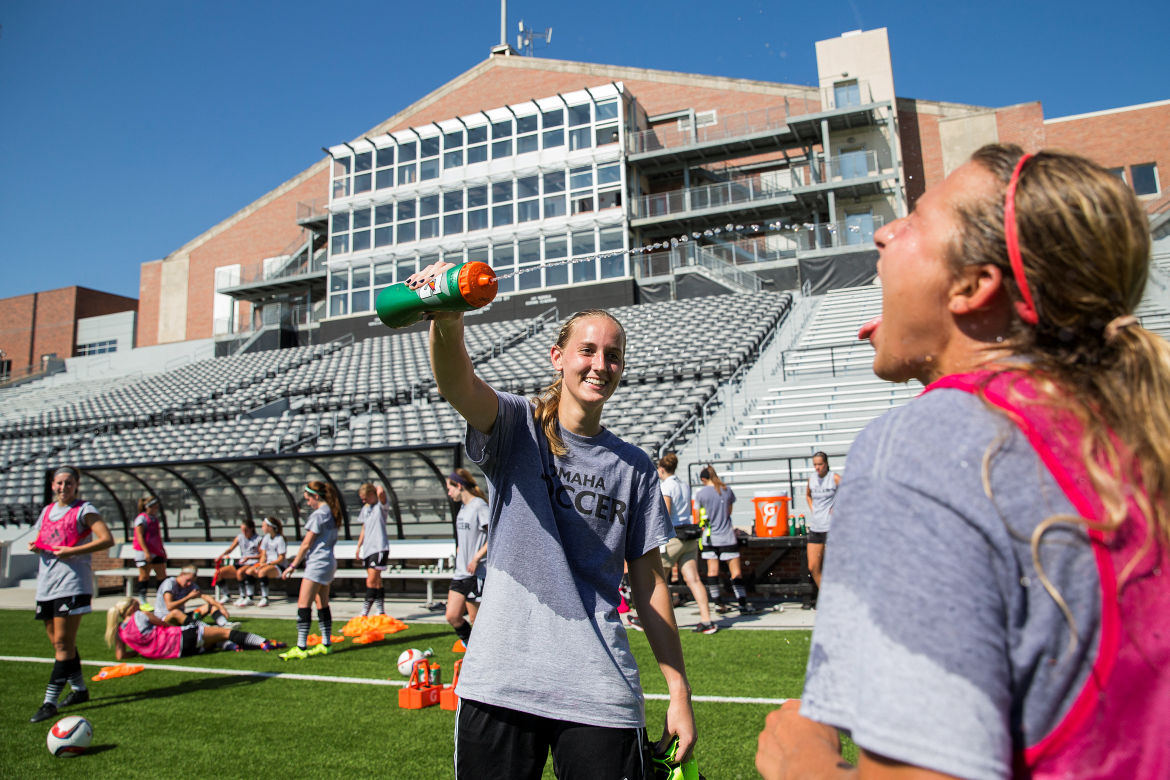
0, 610, 852, 780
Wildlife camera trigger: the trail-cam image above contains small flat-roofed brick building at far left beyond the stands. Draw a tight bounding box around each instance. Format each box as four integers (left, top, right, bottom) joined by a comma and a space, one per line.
0, 287, 138, 379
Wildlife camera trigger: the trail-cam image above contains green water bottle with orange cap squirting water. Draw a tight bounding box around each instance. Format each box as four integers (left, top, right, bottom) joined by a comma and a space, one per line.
374, 261, 498, 327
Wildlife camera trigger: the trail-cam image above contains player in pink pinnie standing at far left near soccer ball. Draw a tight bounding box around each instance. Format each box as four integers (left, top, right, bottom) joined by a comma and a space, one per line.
28, 465, 113, 723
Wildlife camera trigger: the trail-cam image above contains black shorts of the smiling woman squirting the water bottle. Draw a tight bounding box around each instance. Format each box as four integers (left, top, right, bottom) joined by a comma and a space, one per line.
455, 699, 651, 780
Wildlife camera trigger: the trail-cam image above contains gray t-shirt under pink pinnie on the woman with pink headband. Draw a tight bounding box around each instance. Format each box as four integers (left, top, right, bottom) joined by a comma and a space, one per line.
800, 389, 1100, 778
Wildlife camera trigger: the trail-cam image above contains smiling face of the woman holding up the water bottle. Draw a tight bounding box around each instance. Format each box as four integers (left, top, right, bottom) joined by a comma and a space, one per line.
552, 317, 626, 409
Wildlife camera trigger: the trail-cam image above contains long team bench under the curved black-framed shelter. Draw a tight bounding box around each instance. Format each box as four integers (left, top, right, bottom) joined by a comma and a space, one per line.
101, 539, 455, 605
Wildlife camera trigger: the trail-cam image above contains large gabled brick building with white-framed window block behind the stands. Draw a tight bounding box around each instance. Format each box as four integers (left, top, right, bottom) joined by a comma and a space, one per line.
138, 29, 1170, 351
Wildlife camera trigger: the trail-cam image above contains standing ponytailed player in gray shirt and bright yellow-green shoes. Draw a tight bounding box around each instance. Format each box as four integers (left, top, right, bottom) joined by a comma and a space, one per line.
281, 481, 342, 661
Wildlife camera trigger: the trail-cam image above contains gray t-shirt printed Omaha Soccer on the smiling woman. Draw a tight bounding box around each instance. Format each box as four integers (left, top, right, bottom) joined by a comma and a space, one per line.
459, 393, 673, 729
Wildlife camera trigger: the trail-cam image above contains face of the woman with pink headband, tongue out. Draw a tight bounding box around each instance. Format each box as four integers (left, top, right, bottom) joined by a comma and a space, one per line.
869, 163, 997, 384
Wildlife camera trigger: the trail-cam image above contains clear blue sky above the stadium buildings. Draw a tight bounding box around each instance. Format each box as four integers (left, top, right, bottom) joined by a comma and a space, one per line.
0, 0, 1170, 298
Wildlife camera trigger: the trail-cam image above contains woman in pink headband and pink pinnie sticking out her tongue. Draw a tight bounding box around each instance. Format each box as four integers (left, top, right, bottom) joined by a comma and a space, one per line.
756, 145, 1170, 779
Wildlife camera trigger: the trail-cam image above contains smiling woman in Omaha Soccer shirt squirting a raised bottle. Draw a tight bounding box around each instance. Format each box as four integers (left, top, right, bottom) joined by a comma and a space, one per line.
410, 262, 695, 779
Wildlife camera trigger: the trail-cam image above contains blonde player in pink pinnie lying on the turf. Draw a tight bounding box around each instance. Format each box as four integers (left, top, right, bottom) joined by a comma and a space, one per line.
105, 599, 284, 661
